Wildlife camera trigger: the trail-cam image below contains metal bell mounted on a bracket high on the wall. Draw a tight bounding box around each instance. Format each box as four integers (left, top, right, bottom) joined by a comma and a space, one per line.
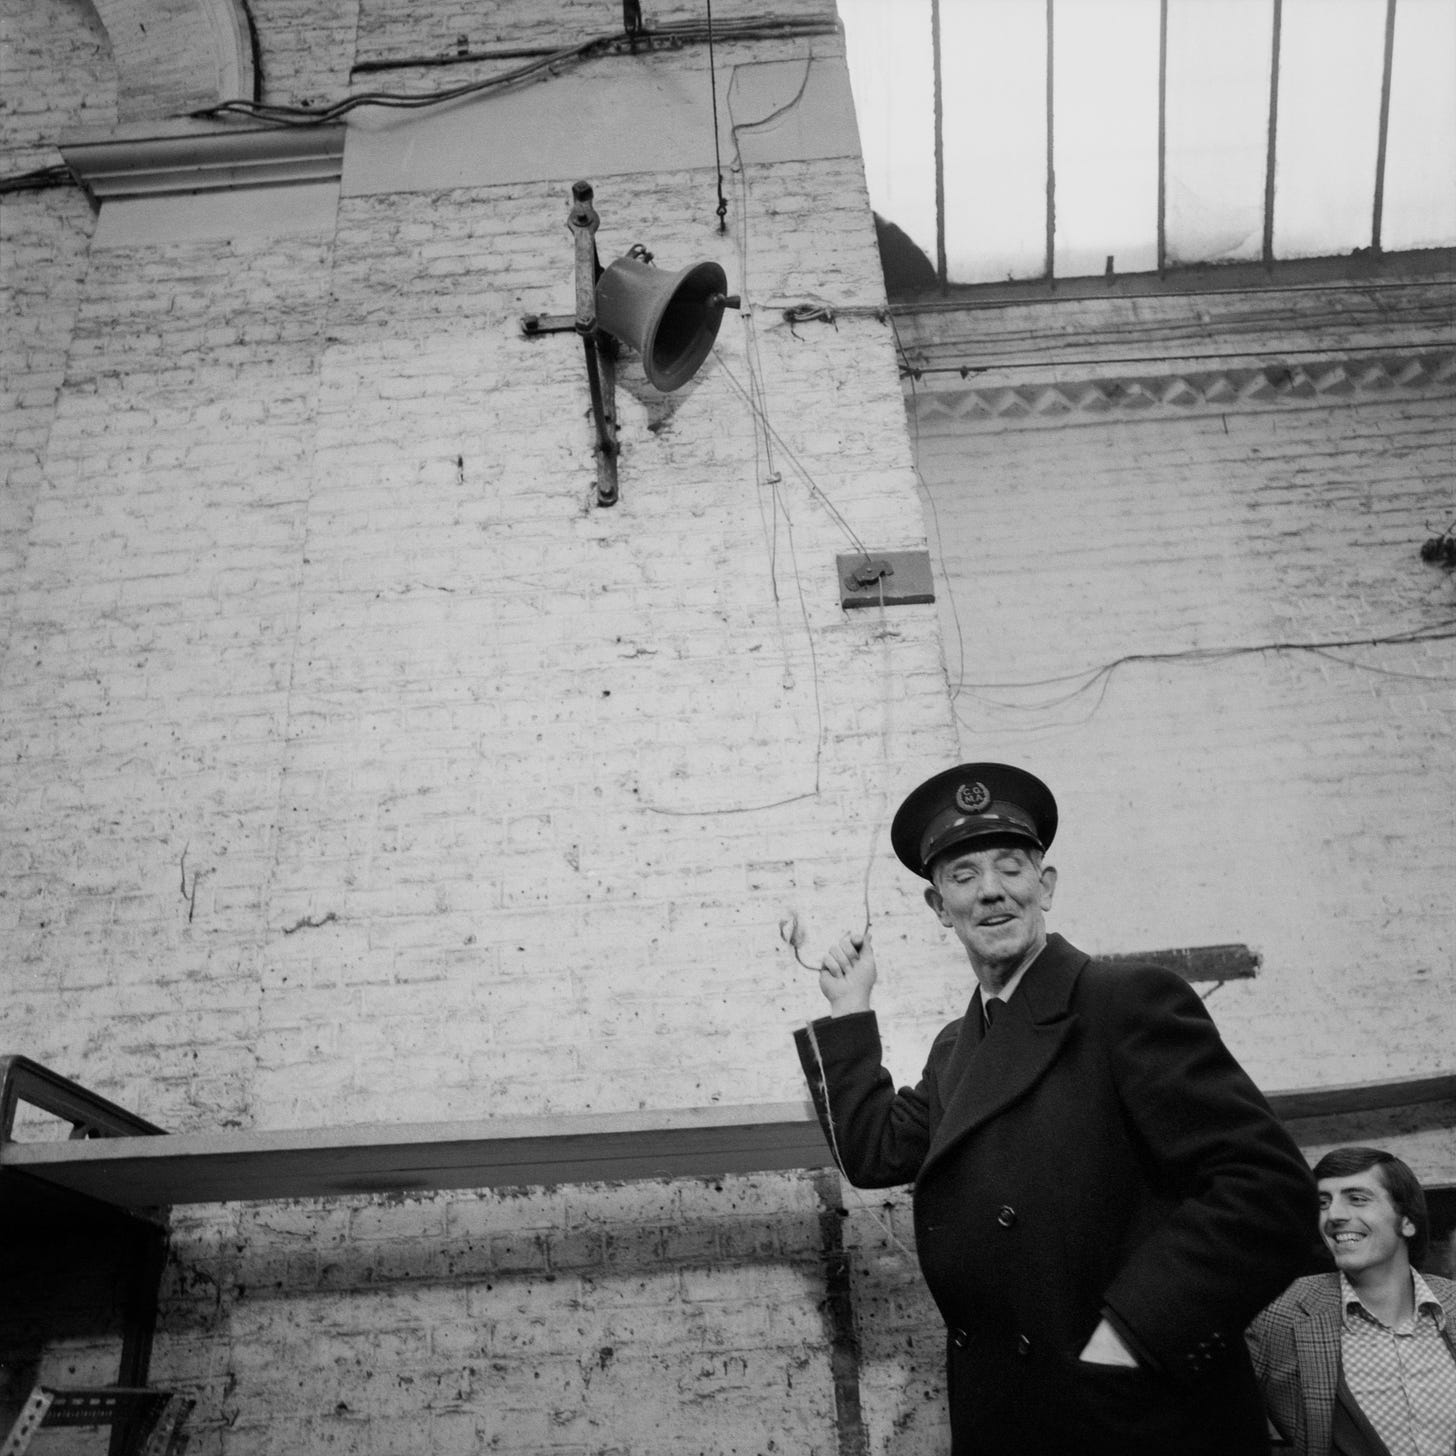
597, 258, 738, 395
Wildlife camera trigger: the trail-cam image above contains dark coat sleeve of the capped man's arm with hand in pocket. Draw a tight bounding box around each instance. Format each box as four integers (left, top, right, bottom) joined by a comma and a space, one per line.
1102, 967, 1318, 1379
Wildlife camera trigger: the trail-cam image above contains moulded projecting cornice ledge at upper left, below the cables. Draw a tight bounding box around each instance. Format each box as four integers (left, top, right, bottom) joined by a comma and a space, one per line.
61, 122, 345, 202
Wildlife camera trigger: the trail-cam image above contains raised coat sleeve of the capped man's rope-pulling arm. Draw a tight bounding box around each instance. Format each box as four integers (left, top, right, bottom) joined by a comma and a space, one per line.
794, 1010, 930, 1188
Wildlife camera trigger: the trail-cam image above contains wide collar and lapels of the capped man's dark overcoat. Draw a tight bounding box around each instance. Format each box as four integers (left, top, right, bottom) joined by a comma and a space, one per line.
917, 935, 1088, 1181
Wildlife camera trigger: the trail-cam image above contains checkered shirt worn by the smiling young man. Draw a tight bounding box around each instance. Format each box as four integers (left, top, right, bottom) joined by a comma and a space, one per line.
1340, 1270, 1456, 1456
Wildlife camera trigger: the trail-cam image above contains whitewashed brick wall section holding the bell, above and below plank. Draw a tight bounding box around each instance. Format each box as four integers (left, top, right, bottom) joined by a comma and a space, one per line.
0, 6, 952, 1456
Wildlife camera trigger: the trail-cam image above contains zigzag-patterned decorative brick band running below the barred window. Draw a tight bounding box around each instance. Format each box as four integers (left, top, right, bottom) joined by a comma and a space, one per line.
904, 345, 1456, 425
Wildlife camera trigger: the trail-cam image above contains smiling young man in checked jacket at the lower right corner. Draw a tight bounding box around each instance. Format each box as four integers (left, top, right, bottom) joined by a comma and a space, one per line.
1248, 1147, 1456, 1456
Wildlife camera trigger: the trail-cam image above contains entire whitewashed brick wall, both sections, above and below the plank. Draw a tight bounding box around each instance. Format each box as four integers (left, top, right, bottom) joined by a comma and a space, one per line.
0, 0, 1456, 1456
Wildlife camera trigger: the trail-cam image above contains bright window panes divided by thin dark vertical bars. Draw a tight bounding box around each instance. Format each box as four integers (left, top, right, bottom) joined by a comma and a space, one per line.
839, 0, 1456, 284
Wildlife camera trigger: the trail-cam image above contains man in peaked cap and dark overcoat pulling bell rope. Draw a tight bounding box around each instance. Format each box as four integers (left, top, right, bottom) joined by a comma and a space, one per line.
795, 763, 1316, 1456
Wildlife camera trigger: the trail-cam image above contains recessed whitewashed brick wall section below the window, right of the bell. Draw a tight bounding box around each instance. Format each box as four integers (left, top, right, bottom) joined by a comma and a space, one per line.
901, 310, 1456, 1094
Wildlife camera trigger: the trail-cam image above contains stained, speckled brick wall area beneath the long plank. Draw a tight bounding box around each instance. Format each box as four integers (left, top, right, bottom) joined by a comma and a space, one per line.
144, 1176, 837, 1456
